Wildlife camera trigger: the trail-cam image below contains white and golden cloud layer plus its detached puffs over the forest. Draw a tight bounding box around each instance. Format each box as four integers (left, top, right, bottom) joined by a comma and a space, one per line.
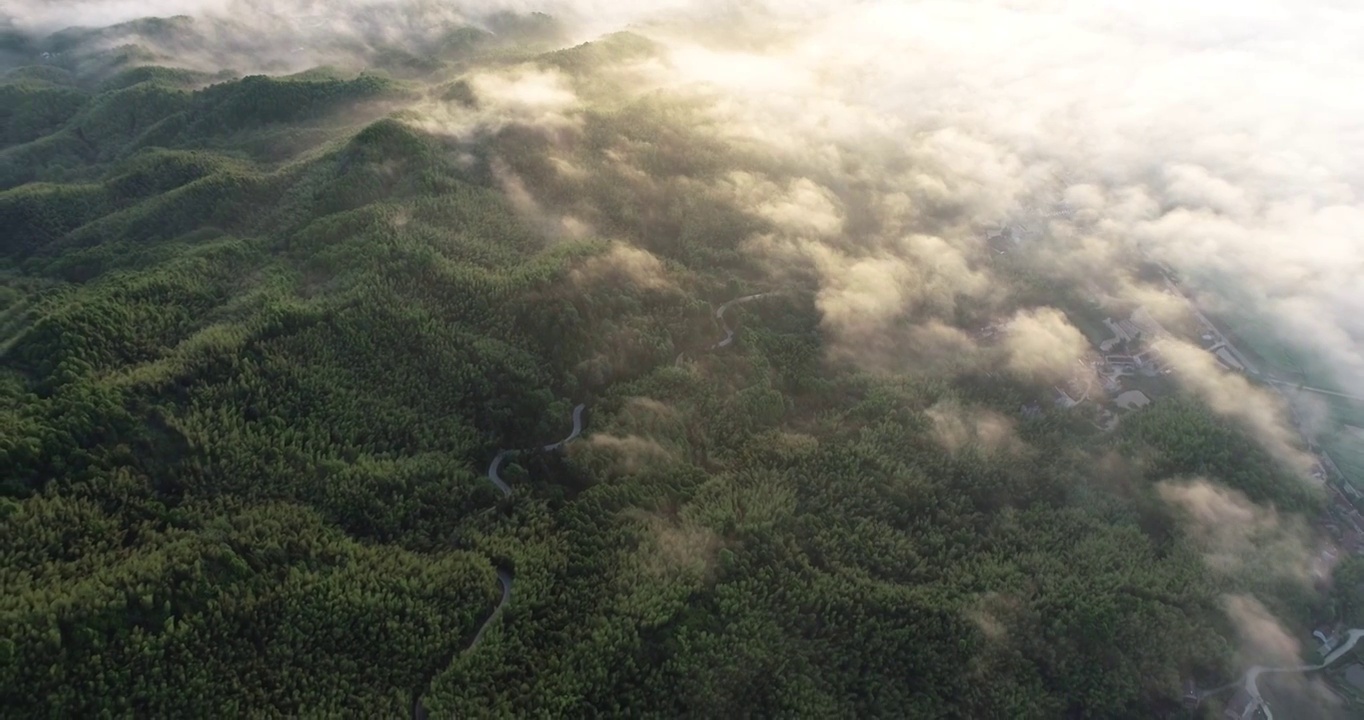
13, 0, 1364, 684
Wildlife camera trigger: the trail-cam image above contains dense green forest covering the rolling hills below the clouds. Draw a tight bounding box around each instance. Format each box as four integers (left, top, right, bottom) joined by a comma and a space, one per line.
0, 11, 1364, 719
